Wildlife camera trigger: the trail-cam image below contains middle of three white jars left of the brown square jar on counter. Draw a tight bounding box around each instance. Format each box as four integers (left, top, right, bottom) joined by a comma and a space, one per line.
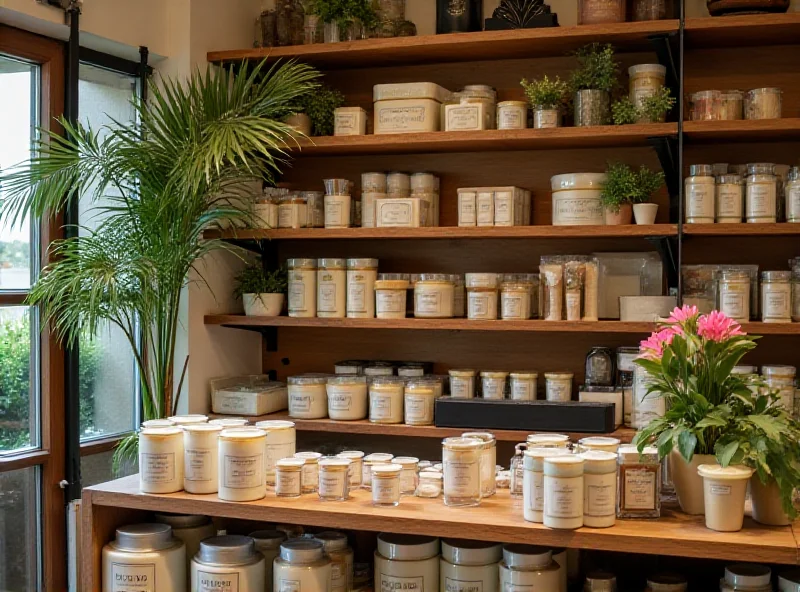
543, 455, 584, 529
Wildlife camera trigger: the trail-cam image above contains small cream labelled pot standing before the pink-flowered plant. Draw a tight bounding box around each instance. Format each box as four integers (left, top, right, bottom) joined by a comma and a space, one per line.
697, 464, 753, 532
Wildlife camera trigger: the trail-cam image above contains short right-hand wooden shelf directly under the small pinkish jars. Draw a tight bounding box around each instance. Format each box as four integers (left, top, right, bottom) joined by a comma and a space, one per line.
683, 118, 800, 144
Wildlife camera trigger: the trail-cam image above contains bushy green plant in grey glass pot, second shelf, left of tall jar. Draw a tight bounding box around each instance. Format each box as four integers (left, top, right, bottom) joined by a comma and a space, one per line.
569, 43, 619, 126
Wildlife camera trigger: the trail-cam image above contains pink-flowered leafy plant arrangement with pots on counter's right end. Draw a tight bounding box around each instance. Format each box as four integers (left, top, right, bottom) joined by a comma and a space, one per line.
634, 306, 800, 530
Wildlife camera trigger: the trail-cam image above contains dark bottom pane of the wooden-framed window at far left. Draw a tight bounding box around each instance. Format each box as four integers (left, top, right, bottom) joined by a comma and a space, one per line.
0, 467, 39, 590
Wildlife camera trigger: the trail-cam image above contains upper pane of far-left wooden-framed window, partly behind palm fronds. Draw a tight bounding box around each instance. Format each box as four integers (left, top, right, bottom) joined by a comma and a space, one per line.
0, 56, 39, 290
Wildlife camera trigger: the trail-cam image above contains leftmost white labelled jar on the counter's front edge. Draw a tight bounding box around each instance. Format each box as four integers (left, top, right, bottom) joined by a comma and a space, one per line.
139, 426, 183, 493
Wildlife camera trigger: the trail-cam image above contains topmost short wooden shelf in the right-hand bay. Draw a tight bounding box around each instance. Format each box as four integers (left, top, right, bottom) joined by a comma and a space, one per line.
685, 13, 800, 49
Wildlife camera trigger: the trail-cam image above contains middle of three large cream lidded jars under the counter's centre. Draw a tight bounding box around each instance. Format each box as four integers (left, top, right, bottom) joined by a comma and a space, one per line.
439, 539, 503, 592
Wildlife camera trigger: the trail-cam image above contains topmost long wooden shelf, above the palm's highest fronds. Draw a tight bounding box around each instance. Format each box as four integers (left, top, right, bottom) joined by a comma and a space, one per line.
207, 20, 678, 69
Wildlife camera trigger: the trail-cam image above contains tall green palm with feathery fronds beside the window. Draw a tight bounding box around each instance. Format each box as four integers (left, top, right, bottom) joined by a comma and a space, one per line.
0, 62, 319, 468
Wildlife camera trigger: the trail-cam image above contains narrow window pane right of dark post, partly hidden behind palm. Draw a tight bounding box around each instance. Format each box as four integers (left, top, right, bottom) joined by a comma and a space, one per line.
79, 64, 138, 442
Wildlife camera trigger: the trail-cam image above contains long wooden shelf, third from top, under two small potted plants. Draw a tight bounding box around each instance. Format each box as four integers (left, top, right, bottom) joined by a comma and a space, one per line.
205, 224, 680, 241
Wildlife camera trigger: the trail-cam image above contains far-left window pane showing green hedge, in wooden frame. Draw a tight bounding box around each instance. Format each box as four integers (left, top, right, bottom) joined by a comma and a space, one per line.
0, 306, 39, 450
